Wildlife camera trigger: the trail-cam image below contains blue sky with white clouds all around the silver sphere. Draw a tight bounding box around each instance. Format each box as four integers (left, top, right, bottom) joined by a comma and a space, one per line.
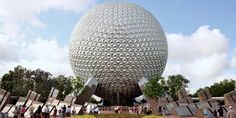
0, 0, 236, 92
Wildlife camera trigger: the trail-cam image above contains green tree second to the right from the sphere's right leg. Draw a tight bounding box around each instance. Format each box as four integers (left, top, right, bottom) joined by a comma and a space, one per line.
165, 74, 189, 100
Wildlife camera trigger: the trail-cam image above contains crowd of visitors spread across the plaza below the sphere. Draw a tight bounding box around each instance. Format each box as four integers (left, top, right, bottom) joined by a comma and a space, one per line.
2, 102, 236, 118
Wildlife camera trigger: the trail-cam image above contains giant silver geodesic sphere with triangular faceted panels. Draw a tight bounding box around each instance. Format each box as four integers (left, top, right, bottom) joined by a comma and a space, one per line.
69, 3, 168, 99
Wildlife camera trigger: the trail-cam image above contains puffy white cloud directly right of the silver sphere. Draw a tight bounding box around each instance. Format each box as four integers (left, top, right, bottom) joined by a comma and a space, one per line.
167, 26, 228, 61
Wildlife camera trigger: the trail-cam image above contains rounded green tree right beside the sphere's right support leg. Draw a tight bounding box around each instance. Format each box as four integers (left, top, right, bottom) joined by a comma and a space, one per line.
144, 76, 165, 100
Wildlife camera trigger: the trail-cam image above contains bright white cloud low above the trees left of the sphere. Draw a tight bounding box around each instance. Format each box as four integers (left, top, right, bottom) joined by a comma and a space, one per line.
0, 38, 73, 75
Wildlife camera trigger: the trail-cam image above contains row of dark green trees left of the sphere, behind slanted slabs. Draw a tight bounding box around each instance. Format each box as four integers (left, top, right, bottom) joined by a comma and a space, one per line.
0, 66, 83, 102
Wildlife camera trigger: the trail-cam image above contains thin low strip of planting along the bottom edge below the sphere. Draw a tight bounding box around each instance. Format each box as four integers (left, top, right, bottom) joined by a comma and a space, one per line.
68, 114, 164, 118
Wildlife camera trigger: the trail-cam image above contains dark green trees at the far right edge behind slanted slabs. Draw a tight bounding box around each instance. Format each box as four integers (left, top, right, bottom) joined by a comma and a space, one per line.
193, 79, 235, 97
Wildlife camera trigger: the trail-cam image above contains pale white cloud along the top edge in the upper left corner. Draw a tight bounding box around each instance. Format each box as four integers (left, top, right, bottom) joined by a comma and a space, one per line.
0, 0, 96, 27
